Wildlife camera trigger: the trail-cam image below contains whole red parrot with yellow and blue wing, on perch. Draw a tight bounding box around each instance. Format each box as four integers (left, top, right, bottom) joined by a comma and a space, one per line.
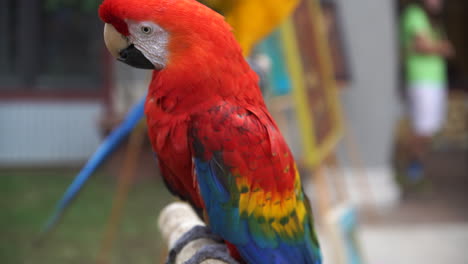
99, 0, 321, 264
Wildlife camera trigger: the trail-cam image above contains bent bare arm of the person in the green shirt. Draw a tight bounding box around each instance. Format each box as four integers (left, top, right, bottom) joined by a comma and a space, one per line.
412, 33, 454, 58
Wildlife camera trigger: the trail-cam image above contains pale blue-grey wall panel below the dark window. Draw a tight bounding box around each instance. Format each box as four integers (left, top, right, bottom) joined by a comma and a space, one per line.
0, 101, 102, 166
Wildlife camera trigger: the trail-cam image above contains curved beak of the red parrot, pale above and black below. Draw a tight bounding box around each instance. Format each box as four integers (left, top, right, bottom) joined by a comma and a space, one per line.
104, 23, 155, 70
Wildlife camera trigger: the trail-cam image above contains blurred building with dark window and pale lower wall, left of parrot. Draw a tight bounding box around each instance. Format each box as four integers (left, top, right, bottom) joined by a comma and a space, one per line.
0, 0, 149, 167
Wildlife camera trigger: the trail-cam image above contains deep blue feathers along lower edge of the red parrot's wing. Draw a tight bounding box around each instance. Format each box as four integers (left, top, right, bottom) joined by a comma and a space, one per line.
195, 159, 321, 264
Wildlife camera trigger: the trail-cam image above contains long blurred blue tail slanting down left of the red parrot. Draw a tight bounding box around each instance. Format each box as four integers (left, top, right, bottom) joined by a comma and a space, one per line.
41, 96, 146, 236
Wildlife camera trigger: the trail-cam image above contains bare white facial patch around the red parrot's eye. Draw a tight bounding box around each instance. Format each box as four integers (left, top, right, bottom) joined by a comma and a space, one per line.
126, 20, 169, 69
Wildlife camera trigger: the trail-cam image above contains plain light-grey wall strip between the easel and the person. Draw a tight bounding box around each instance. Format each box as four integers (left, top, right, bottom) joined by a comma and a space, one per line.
337, 0, 401, 205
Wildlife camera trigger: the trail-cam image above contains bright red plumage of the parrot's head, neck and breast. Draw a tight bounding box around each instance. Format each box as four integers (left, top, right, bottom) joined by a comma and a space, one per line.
99, 0, 292, 211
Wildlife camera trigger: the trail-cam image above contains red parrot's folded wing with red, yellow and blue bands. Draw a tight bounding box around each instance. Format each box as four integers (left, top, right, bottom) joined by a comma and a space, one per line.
189, 103, 321, 264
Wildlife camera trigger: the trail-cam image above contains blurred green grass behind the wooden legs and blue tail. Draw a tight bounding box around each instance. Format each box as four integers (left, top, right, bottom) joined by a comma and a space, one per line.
0, 170, 172, 264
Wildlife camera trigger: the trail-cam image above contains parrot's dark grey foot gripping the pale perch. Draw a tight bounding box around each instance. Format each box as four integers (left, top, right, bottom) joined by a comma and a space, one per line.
166, 226, 238, 264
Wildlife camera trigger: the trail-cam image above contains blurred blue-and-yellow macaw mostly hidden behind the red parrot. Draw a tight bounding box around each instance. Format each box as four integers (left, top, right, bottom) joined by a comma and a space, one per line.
41, 0, 298, 235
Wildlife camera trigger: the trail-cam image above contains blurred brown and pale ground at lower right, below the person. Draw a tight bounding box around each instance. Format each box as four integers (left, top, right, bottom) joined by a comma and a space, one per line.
359, 150, 468, 264
